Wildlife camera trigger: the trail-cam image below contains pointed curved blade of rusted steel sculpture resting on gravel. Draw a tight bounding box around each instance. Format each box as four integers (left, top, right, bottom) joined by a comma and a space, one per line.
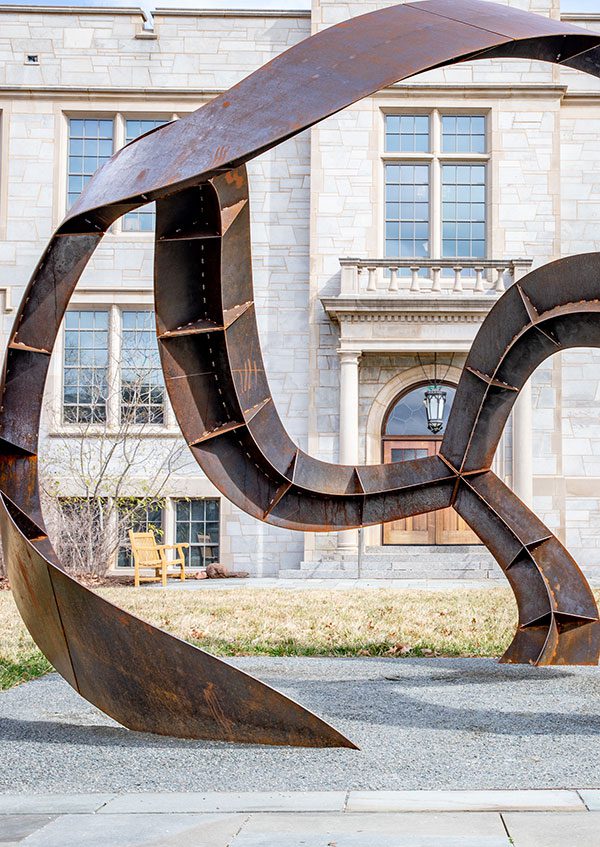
0, 496, 356, 749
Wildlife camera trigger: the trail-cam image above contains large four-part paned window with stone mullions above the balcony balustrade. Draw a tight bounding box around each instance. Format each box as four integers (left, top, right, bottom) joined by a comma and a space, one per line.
385, 110, 487, 262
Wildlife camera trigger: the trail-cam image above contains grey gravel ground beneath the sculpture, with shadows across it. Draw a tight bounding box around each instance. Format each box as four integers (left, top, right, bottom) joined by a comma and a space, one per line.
0, 658, 600, 793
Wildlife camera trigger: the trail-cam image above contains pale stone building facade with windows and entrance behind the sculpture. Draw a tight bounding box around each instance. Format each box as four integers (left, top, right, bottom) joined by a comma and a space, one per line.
0, 0, 600, 577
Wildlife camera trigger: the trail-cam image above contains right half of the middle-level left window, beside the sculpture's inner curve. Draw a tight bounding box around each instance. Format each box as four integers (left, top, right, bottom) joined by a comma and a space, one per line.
121, 310, 165, 424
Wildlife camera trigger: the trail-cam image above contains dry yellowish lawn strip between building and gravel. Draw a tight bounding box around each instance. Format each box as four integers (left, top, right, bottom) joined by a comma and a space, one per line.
0, 587, 600, 688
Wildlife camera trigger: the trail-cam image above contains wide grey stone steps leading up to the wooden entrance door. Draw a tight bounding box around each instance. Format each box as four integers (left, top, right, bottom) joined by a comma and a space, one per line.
279, 545, 503, 580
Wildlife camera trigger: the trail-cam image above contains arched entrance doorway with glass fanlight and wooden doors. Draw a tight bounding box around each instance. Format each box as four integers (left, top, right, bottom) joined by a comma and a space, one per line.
382, 382, 481, 545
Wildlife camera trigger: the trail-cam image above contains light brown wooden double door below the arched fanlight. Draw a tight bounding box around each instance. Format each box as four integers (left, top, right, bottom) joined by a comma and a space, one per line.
383, 438, 481, 544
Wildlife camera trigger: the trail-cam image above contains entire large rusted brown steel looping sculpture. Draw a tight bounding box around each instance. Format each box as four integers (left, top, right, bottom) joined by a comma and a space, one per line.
0, 0, 600, 747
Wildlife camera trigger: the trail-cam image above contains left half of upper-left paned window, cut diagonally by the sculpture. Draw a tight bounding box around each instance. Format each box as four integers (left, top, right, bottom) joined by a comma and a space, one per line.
67, 118, 114, 208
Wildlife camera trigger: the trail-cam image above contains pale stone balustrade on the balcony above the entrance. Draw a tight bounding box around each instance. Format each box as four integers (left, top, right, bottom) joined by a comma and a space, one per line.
340, 258, 532, 297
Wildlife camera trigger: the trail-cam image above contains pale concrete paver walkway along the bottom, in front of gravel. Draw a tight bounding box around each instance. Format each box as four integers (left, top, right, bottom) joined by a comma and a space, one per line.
0, 790, 600, 847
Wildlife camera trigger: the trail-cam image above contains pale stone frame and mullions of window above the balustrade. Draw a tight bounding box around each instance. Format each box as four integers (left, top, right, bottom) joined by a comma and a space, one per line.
378, 103, 492, 259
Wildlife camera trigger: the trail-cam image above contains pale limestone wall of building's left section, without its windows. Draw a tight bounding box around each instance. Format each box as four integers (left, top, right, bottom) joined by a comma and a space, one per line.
0, 9, 310, 574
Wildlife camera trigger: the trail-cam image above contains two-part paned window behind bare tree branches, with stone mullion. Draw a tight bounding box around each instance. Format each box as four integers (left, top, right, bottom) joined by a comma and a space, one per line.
63, 309, 166, 427
